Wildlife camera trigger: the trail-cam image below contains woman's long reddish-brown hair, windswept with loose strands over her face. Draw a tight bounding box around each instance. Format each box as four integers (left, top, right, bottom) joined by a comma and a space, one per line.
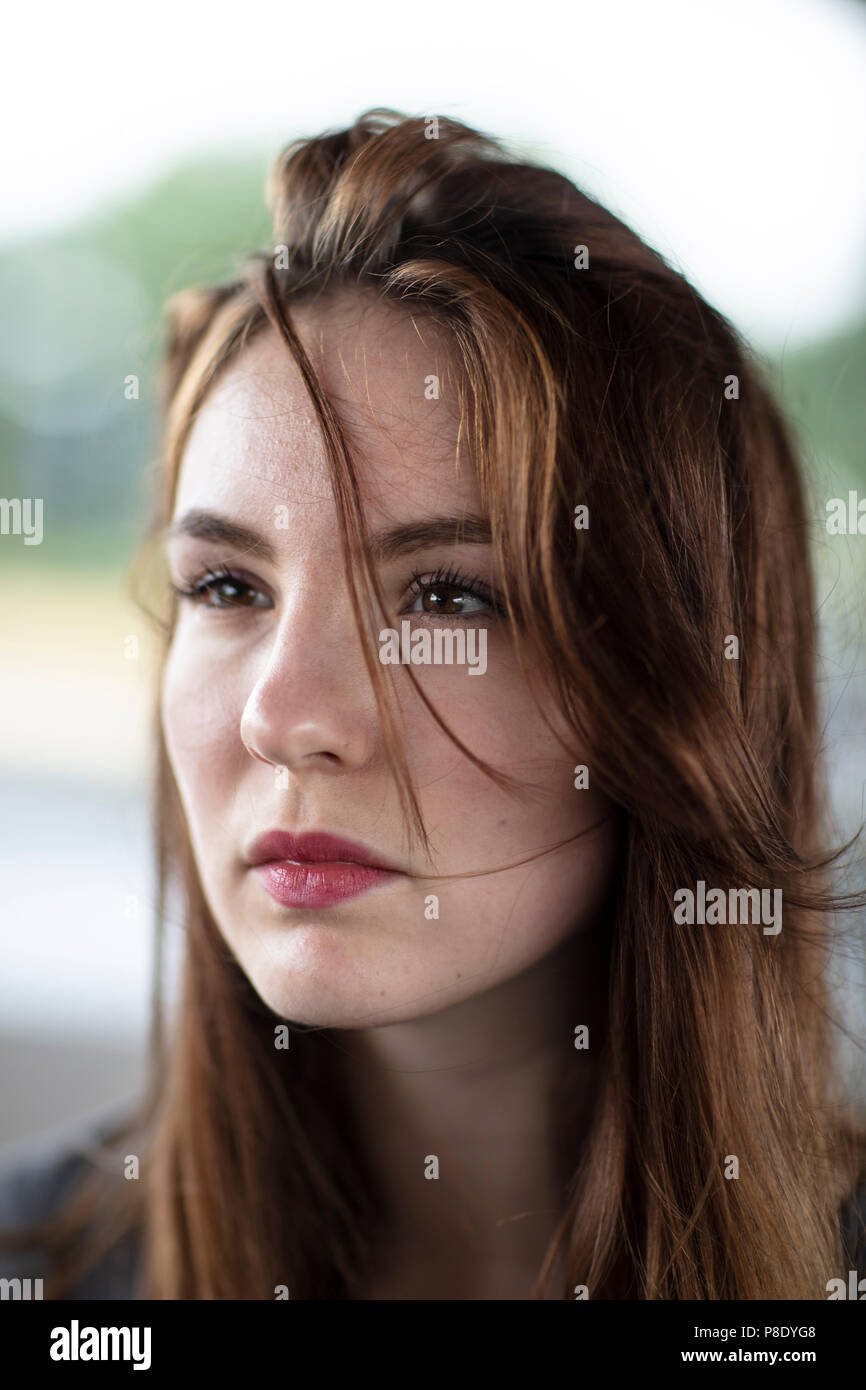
3, 110, 865, 1298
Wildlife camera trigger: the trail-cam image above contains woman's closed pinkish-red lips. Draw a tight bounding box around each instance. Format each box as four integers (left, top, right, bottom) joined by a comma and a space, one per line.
247, 830, 399, 908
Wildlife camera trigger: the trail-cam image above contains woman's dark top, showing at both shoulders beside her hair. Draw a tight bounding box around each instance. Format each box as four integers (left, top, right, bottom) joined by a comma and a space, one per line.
0, 1111, 866, 1300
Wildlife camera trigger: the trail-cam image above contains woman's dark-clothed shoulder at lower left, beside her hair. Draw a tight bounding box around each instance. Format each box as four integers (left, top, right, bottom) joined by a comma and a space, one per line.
0, 1104, 139, 1298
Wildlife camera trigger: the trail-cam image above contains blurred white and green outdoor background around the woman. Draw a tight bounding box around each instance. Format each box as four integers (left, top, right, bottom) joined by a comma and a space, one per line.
0, 0, 866, 1143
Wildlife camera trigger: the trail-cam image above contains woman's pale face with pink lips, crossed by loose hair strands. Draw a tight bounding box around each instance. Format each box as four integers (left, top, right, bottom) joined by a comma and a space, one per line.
163, 293, 614, 1027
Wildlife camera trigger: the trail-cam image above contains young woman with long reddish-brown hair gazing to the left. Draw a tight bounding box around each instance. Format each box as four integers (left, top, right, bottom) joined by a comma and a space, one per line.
4, 111, 866, 1300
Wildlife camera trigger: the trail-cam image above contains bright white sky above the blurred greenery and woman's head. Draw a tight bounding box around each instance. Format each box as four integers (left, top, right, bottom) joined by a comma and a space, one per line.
0, 0, 866, 345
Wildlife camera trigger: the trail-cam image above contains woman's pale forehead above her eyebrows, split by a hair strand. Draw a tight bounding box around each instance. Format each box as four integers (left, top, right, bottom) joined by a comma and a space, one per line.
175, 304, 477, 513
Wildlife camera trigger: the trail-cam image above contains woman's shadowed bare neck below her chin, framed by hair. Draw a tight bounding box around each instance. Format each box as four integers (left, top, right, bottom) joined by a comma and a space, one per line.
342, 935, 602, 1298
